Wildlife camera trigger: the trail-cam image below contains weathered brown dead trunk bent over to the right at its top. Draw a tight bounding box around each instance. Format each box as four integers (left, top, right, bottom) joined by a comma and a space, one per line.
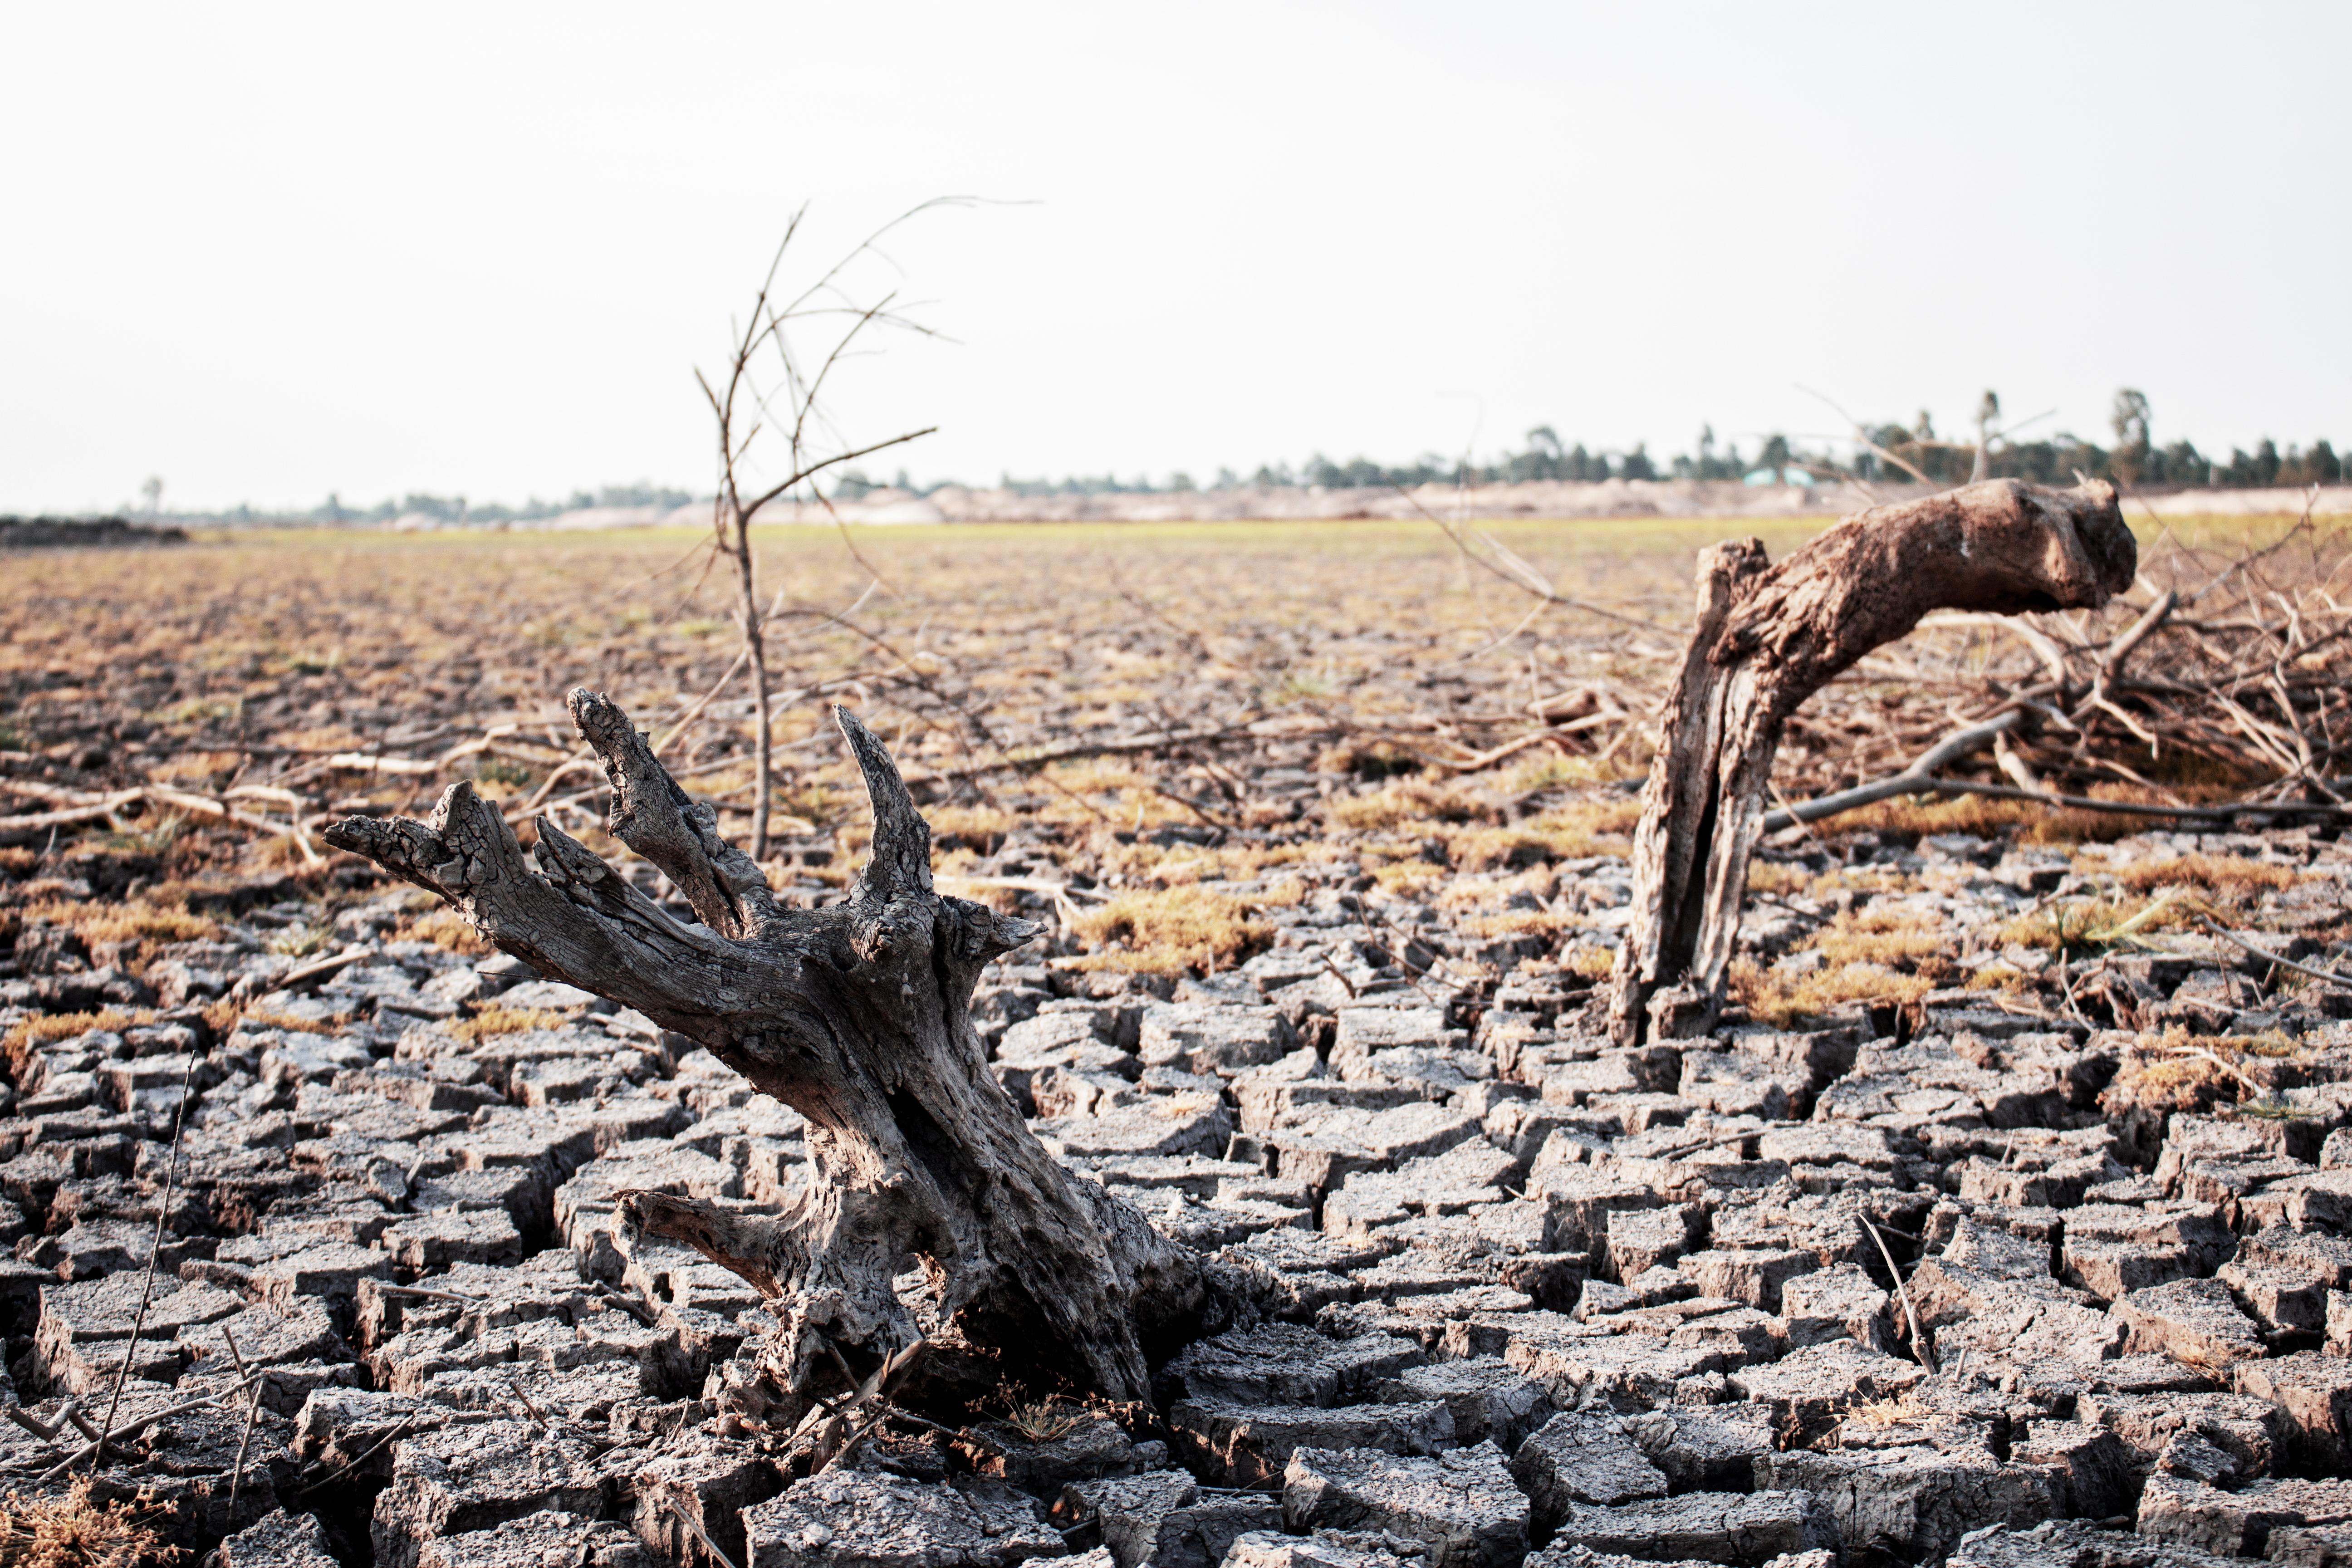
1609, 480, 2138, 1044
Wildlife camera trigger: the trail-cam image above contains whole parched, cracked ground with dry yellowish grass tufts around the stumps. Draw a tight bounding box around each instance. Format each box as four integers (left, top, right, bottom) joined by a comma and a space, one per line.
0, 522, 2352, 1568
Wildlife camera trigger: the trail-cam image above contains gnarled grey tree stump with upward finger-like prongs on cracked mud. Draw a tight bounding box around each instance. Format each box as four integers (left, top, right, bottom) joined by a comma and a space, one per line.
327, 689, 1204, 1399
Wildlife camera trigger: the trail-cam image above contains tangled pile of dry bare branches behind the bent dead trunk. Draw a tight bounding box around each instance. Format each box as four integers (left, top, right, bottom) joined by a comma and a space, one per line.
1766, 496, 2352, 830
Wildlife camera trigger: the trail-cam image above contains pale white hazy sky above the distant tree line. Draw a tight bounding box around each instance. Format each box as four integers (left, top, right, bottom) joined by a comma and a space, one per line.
0, 0, 2352, 510
